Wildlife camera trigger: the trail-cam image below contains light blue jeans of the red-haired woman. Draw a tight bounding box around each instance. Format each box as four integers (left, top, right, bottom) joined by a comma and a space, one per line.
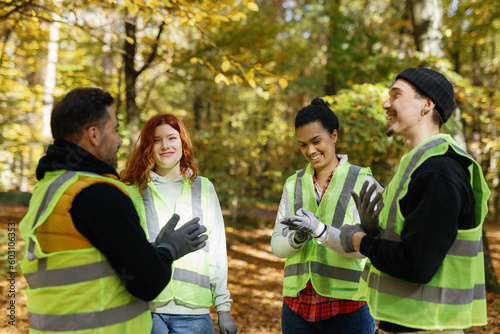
151, 313, 215, 334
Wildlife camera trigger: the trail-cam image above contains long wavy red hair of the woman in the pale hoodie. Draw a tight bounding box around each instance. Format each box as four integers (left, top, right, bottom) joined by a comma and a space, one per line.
120, 114, 198, 194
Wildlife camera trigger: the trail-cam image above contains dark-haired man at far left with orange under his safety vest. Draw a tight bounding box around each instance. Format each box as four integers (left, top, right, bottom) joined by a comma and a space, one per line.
20, 88, 207, 334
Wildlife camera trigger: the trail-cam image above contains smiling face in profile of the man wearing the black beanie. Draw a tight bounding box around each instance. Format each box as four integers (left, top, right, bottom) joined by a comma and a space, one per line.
382, 79, 425, 137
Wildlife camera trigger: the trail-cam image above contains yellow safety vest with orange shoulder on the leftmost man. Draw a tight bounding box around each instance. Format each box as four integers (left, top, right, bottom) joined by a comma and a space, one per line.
19, 171, 152, 334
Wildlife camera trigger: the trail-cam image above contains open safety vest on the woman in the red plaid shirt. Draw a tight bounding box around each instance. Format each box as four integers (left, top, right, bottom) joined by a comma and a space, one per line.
283, 162, 370, 299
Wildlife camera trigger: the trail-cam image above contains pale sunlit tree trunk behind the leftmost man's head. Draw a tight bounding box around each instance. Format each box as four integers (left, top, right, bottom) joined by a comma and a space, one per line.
42, 1, 61, 145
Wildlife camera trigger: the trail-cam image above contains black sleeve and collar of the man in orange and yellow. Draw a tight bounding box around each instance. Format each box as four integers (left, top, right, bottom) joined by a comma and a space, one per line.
37, 141, 173, 301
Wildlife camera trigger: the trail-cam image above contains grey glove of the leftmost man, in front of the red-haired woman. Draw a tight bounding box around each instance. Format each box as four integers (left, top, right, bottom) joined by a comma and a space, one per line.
153, 213, 208, 261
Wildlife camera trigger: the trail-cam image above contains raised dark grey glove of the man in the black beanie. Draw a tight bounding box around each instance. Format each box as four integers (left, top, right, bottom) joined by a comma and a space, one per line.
351, 181, 384, 237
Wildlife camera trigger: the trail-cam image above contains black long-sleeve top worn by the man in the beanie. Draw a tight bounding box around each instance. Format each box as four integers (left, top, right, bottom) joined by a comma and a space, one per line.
360, 149, 475, 332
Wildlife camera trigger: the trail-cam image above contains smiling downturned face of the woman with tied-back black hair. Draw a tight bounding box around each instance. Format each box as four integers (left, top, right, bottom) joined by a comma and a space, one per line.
295, 122, 337, 172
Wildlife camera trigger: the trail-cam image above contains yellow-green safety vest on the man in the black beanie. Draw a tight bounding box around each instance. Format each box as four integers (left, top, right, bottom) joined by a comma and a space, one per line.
359, 134, 490, 330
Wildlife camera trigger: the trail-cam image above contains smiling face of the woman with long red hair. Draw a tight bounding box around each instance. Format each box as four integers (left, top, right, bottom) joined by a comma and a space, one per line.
153, 124, 182, 176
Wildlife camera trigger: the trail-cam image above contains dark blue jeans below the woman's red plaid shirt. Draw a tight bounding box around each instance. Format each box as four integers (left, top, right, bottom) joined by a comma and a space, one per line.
281, 302, 376, 334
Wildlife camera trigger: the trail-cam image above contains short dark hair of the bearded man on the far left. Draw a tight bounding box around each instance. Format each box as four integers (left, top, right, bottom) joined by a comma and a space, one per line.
50, 88, 115, 141
